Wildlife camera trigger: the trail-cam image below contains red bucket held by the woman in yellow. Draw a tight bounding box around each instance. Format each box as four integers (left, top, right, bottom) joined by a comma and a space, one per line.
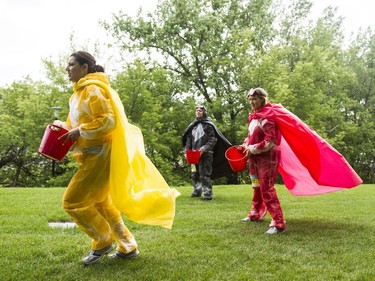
38, 124, 73, 161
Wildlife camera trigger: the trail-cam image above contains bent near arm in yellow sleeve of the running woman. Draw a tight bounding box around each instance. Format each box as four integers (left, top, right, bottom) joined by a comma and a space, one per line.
78, 85, 115, 139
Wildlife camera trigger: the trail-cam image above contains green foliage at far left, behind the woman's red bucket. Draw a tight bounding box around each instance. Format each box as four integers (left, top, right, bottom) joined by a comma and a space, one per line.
0, 50, 71, 186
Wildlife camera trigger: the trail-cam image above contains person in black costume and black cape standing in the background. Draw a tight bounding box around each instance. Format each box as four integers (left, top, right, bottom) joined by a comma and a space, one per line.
182, 106, 232, 200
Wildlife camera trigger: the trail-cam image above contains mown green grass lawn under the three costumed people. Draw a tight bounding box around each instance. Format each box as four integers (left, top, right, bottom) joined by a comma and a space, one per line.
0, 185, 375, 281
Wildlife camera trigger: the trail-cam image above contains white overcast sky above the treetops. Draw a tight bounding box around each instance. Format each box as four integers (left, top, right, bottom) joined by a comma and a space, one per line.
0, 0, 375, 86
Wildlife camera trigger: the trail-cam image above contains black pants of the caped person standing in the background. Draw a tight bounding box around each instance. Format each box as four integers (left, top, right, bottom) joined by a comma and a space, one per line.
192, 152, 213, 199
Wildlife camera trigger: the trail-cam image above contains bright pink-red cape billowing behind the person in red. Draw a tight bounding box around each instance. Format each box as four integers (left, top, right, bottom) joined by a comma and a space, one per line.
255, 103, 362, 196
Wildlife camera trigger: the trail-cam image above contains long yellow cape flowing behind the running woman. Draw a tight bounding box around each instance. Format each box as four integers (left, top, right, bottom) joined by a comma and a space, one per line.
75, 73, 180, 229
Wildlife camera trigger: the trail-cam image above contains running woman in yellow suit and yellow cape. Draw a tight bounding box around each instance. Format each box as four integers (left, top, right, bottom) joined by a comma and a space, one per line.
55, 51, 179, 265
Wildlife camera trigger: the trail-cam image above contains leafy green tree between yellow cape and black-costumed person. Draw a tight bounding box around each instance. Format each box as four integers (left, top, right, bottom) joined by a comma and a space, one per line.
112, 60, 194, 185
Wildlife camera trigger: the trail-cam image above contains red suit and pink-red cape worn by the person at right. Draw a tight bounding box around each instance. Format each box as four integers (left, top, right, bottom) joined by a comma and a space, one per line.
244, 103, 362, 229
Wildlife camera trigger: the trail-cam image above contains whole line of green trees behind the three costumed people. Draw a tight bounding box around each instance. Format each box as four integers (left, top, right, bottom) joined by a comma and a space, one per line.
0, 0, 375, 187
